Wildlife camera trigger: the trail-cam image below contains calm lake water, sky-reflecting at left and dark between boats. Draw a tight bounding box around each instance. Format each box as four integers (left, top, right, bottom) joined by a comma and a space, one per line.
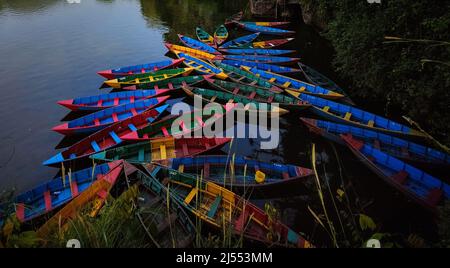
0, 0, 442, 247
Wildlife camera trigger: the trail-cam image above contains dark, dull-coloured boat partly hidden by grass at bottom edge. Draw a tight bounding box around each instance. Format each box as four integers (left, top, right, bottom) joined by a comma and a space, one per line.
136, 171, 197, 248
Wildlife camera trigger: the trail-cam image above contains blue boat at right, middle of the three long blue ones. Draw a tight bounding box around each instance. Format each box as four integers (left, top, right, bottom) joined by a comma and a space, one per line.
301, 118, 450, 165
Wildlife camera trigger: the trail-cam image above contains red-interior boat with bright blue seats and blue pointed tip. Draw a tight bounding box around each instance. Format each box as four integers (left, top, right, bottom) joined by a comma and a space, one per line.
43, 104, 169, 166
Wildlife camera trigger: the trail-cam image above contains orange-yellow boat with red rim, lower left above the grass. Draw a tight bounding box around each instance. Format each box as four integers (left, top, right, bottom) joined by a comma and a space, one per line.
36, 161, 125, 237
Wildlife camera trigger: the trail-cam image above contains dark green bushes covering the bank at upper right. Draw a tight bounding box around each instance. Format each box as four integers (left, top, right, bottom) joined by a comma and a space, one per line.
300, 0, 450, 144
